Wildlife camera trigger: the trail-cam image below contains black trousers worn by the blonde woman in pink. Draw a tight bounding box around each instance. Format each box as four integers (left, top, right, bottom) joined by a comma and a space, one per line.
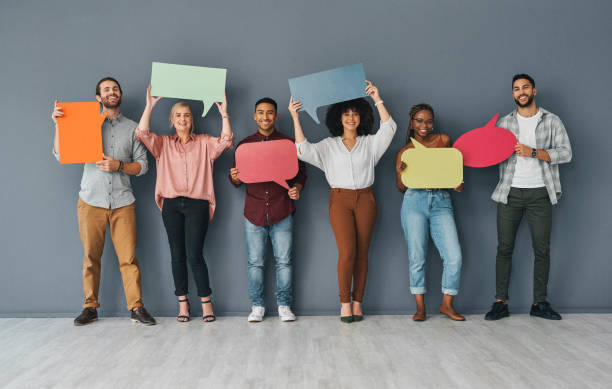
162, 197, 212, 297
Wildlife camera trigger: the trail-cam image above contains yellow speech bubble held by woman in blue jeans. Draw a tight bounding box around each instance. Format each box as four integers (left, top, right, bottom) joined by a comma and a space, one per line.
402, 138, 463, 189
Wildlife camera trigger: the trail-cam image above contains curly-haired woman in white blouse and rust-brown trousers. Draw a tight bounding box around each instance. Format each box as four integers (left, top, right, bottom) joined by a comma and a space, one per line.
289, 81, 397, 323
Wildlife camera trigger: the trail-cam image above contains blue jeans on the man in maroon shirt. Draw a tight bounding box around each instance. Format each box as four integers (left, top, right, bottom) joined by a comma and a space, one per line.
244, 215, 293, 307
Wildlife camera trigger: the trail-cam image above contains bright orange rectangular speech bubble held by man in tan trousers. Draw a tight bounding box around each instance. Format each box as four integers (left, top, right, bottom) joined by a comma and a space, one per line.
57, 101, 106, 163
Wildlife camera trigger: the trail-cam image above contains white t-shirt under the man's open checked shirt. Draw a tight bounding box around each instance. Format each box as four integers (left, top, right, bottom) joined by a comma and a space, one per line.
512, 110, 546, 188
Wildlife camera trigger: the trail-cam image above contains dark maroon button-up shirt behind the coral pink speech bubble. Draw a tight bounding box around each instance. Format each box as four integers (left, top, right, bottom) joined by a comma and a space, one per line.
229, 130, 306, 226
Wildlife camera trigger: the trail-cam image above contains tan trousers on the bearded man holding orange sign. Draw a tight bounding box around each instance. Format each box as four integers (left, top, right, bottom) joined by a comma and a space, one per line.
77, 199, 142, 310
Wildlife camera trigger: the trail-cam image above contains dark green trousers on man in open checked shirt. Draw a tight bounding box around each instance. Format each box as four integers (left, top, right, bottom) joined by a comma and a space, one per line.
495, 188, 552, 303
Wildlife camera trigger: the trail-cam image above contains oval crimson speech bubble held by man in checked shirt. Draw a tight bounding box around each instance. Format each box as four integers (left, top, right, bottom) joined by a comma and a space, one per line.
453, 114, 517, 167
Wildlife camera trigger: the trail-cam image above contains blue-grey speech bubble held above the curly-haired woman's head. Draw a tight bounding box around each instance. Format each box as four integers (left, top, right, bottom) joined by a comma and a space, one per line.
289, 64, 367, 124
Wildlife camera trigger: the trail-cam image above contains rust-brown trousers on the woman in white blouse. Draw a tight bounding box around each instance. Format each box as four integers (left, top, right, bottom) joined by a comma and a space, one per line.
329, 188, 377, 303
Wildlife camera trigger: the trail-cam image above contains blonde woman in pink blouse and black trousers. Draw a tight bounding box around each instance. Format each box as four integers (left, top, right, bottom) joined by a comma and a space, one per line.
136, 86, 234, 322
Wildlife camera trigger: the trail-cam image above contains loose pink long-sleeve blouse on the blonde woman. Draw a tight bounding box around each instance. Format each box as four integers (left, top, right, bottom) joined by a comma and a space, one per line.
136, 127, 234, 221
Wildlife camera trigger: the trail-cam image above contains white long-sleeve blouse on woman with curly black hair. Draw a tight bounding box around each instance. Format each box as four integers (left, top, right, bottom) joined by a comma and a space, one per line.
295, 118, 397, 189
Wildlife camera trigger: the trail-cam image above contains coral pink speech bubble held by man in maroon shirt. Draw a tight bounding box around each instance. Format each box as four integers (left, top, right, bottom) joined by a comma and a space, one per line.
236, 139, 298, 189
